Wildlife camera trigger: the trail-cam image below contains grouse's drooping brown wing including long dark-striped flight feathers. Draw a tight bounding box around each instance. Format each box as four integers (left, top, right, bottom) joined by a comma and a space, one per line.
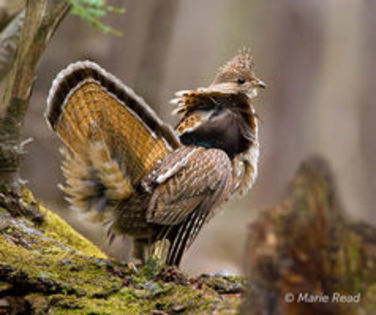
143, 146, 232, 265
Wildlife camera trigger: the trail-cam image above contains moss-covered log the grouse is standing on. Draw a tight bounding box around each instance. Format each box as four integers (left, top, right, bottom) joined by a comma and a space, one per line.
0, 187, 245, 314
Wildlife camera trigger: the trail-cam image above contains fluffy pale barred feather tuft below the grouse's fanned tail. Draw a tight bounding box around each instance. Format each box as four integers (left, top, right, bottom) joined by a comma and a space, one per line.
59, 142, 133, 221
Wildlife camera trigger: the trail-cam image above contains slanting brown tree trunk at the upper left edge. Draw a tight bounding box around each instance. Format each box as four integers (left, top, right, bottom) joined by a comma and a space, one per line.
0, 0, 70, 190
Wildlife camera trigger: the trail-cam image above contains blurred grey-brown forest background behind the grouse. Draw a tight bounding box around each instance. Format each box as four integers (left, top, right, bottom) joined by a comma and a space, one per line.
21, 0, 376, 274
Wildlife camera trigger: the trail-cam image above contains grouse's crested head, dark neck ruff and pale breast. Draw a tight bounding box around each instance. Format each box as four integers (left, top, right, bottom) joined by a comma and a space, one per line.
171, 49, 266, 196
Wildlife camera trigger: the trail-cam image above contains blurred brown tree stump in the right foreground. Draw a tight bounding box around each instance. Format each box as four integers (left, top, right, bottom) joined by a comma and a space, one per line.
243, 158, 376, 315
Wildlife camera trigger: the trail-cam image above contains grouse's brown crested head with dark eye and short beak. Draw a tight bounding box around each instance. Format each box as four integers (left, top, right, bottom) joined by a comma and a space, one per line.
209, 49, 266, 98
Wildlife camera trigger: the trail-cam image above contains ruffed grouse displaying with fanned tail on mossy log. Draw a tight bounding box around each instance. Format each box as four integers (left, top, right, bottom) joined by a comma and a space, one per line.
45, 49, 266, 266
